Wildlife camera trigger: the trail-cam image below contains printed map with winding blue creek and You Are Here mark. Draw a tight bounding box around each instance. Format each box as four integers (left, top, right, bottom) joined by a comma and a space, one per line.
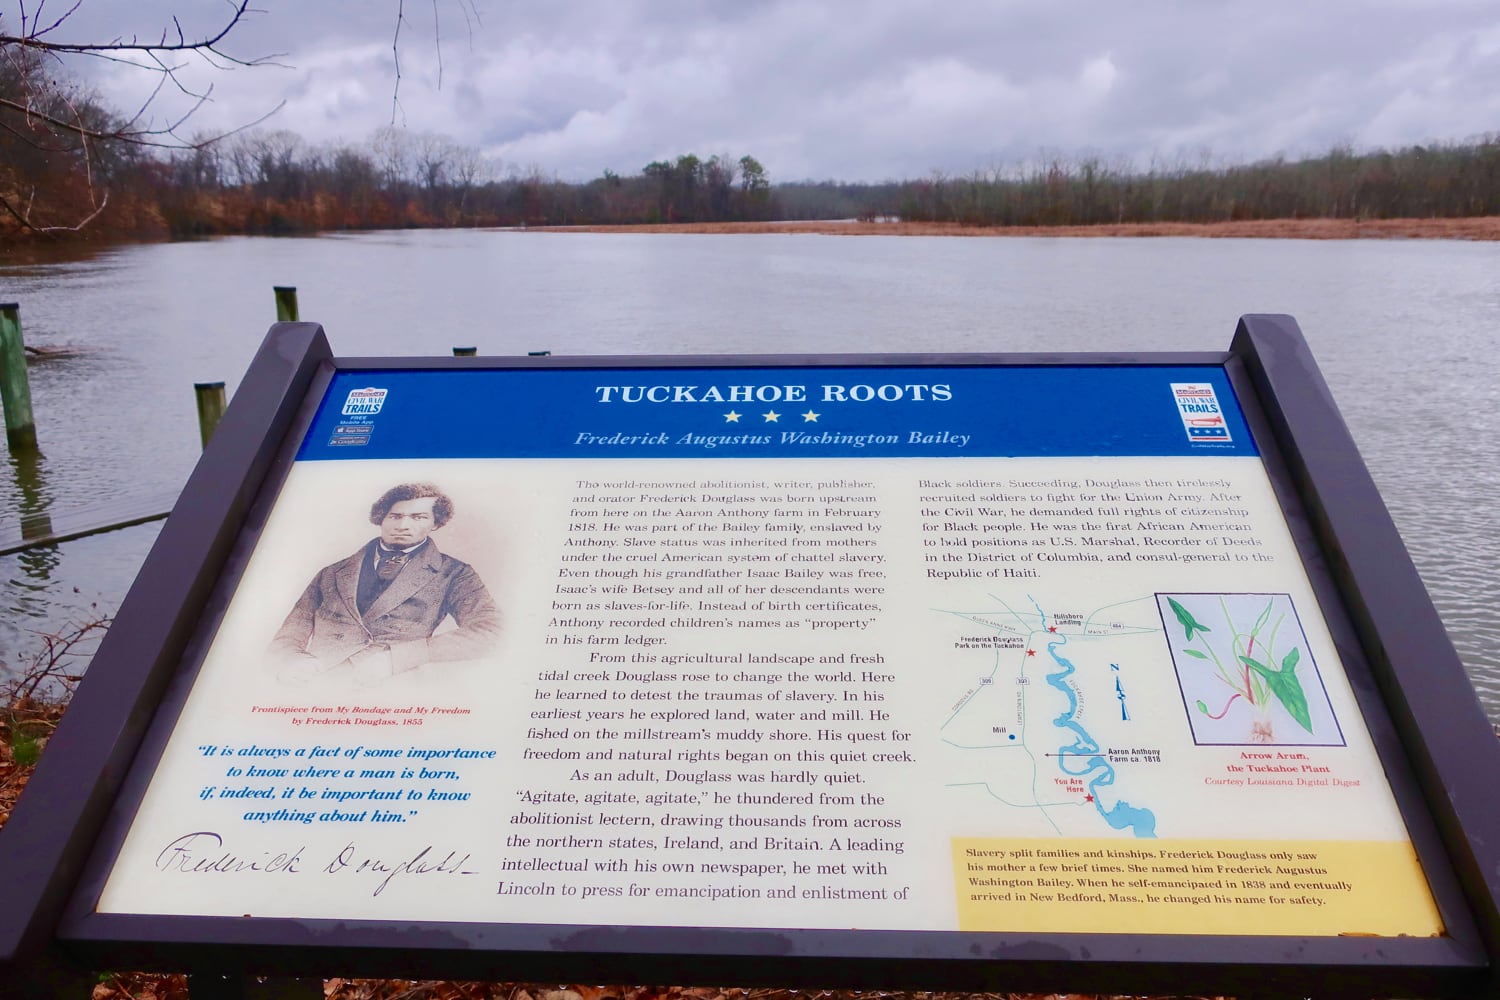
941, 598, 1161, 837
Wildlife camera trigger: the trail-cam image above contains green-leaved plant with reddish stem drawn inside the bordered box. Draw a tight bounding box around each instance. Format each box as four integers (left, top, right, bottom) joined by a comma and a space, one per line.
1167, 597, 1313, 744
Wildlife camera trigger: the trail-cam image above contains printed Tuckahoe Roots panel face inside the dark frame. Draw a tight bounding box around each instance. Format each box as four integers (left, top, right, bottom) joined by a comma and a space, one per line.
98, 364, 1445, 937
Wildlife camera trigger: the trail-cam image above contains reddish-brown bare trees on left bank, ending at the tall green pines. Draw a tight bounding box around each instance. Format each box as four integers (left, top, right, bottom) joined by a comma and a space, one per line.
0, 30, 777, 237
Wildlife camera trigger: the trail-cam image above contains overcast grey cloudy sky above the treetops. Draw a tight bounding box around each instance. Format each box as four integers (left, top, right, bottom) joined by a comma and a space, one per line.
29, 0, 1500, 181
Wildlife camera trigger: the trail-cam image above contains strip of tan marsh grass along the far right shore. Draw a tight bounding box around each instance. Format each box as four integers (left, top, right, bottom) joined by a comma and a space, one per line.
549, 216, 1500, 241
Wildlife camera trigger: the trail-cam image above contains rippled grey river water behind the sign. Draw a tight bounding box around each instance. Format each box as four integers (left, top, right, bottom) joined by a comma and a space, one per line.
0, 231, 1500, 720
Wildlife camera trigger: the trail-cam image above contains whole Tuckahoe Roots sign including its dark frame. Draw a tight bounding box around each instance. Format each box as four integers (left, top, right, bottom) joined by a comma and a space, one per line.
0, 316, 1500, 1000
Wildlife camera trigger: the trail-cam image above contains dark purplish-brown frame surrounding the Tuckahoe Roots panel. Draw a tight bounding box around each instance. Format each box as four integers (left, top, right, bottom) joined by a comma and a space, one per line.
0, 315, 1500, 997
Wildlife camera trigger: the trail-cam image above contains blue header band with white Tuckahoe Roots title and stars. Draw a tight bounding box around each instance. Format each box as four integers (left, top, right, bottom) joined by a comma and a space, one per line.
297, 366, 1257, 460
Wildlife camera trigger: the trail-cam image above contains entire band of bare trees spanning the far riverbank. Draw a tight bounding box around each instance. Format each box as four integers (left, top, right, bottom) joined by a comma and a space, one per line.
0, 34, 1500, 238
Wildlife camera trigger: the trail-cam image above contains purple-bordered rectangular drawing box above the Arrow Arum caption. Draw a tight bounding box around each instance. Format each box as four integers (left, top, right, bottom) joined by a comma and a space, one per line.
1157, 594, 1344, 747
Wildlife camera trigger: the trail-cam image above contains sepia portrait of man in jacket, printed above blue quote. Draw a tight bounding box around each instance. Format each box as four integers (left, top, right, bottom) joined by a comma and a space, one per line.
272, 483, 500, 684
